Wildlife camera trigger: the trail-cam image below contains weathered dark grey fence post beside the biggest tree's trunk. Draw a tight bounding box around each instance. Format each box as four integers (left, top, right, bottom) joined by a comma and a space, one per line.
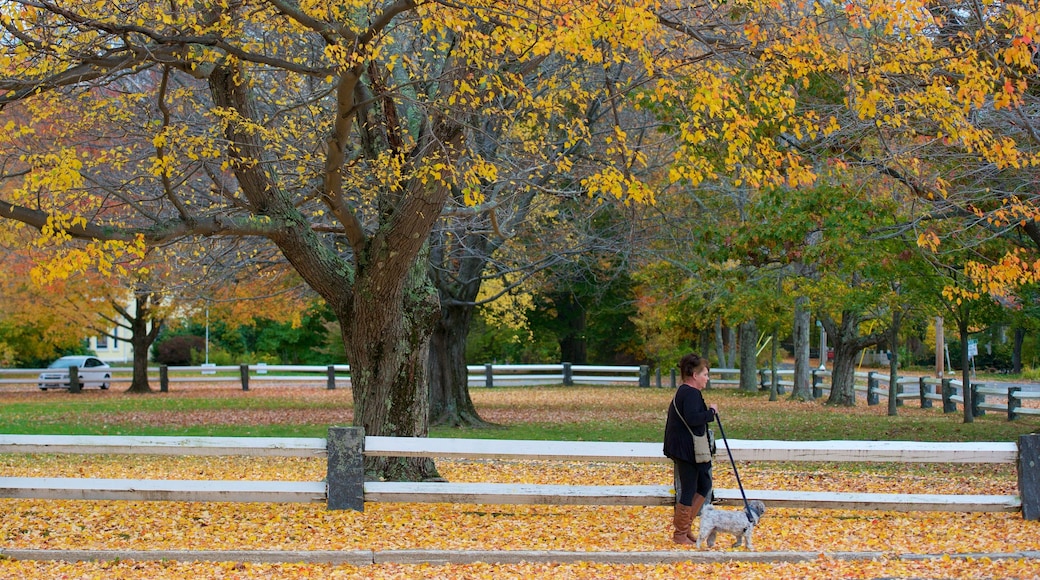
326, 427, 365, 511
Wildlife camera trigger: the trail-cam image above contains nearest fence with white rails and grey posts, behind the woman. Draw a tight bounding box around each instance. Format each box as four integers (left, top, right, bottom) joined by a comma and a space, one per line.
0, 427, 1040, 520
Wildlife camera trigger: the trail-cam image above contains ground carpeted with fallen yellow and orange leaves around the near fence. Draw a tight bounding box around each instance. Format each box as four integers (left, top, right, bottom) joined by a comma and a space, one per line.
0, 389, 1040, 578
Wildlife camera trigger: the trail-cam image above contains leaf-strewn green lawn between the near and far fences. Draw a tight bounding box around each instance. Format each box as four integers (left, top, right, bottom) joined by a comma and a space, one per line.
0, 386, 1040, 442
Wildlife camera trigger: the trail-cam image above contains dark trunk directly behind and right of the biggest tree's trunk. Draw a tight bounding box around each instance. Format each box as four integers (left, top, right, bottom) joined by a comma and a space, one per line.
430, 300, 489, 427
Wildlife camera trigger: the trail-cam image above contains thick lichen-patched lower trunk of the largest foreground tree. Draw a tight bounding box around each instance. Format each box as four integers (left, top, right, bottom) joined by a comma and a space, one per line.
337, 252, 440, 481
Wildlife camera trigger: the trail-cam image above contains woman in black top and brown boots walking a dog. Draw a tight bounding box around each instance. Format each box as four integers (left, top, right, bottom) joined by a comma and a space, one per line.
665, 353, 719, 546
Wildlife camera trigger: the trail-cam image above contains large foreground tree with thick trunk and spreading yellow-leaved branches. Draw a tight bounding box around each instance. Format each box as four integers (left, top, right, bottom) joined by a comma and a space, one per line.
0, 0, 682, 478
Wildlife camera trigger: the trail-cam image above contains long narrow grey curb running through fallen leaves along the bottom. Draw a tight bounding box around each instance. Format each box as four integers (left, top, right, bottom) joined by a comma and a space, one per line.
0, 550, 1040, 565
